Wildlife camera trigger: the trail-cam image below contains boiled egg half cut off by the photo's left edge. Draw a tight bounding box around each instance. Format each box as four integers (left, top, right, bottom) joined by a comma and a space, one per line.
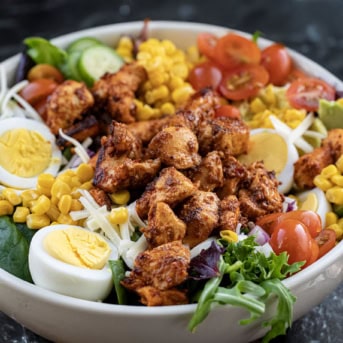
0, 118, 62, 189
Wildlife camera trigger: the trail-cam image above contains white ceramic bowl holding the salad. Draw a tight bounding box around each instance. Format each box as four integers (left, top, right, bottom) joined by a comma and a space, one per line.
0, 22, 343, 343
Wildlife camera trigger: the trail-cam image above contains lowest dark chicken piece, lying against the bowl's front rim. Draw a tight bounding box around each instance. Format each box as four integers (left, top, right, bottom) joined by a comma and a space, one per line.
137, 286, 188, 306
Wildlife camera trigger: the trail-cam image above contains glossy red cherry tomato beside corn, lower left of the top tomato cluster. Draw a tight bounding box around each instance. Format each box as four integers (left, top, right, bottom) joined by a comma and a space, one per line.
188, 61, 222, 90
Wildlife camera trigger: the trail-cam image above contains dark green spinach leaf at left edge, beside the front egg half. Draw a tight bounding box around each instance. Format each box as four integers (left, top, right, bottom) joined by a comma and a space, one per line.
0, 216, 32, 282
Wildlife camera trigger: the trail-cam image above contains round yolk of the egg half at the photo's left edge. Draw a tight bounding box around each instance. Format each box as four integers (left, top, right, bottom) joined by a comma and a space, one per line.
0, 129, 52, 177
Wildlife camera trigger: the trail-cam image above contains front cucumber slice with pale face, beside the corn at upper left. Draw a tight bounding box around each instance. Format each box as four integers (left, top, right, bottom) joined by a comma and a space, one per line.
78, 45, 124, 86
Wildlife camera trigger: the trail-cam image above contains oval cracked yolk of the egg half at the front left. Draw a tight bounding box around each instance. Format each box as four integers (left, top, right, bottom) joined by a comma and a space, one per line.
43, 228, 111, 269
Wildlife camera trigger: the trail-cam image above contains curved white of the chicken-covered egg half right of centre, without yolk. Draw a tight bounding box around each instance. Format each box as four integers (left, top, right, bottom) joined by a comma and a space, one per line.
246, 129, 299, 194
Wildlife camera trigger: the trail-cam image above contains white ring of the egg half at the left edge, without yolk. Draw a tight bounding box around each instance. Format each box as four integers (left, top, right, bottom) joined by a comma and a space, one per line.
0, 118, 62, 189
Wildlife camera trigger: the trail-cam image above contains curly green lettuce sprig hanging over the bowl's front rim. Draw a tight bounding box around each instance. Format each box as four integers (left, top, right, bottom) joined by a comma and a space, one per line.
188, 237, 304, 343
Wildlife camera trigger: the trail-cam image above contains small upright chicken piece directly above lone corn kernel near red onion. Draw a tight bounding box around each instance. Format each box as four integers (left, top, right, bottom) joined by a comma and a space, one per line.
218, 195, 241, 231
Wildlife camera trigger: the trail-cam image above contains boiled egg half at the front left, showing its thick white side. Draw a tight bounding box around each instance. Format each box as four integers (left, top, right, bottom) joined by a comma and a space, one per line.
29, 224, 118, 301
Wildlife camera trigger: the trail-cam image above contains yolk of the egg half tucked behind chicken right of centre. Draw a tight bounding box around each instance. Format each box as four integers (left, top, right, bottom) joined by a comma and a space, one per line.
239, 132, 288, 175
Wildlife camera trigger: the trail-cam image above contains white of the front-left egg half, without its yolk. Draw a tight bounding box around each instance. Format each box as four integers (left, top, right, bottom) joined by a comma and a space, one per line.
29, 224, 118, 301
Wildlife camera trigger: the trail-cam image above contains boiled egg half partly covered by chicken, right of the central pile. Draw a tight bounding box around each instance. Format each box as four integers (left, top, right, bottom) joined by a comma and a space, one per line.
238, 129, 299, 193
